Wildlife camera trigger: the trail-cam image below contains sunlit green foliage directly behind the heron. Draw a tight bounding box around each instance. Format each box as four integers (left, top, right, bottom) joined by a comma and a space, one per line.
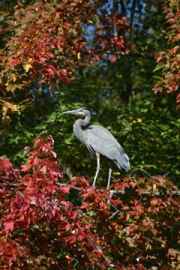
0, 83, 180, 184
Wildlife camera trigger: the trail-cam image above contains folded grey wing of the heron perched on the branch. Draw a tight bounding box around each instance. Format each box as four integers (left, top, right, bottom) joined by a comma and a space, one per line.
86, 125, 130, 170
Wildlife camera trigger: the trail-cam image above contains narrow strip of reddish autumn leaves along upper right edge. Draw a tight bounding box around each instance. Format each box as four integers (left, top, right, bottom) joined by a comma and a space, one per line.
153, 0, 180, 108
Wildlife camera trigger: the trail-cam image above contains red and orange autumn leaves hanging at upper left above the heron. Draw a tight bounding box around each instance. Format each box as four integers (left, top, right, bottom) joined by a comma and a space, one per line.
0, 0, 131, 122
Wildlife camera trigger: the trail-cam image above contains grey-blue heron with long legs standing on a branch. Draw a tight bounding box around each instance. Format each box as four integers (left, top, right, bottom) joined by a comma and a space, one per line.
63, 108, 130, 189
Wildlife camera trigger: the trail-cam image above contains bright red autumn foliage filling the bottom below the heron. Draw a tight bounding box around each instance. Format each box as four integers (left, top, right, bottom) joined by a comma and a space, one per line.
0, 132, 180, 269
